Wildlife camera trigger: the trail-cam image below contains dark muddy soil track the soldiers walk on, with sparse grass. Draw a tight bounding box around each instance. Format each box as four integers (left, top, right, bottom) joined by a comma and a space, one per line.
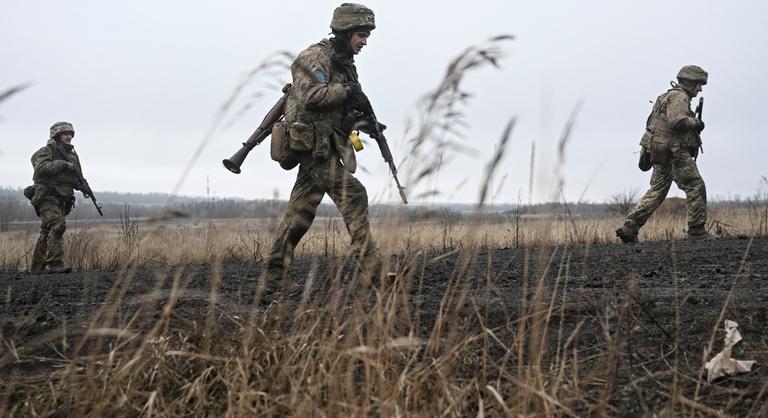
0, 237, 768, 416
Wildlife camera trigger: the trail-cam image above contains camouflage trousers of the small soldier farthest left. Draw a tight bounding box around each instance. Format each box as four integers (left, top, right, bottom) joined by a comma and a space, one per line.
31, 196, 69, 272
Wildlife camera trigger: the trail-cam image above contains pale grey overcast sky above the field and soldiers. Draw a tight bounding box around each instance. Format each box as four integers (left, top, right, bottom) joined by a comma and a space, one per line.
0, 0, 768, 203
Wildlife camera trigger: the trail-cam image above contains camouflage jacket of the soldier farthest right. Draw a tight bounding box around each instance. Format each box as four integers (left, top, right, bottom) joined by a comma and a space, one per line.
640, 87, 698, 148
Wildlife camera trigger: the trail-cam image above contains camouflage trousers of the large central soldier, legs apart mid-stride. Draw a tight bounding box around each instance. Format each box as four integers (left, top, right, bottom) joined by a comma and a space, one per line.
269, 157, 381, 274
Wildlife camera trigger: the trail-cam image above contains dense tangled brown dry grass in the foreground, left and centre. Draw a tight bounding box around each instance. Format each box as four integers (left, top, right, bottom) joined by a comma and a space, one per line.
0, 240, 582, 416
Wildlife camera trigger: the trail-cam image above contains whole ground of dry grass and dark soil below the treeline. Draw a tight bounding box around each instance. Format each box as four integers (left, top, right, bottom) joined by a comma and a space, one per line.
0, 210, 768, 417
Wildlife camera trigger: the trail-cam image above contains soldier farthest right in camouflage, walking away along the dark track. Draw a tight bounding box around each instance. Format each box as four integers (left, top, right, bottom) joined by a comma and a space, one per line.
616, 65, 707, 243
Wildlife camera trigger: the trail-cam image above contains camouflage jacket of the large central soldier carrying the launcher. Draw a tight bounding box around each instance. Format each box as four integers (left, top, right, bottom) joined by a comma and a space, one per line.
285, 39, 357, 172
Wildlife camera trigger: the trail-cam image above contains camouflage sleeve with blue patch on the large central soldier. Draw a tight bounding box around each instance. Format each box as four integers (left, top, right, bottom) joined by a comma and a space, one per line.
291, 48, 347, 110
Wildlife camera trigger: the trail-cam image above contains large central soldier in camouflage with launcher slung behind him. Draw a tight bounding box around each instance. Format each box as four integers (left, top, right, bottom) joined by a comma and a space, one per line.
268, 3, 381, 277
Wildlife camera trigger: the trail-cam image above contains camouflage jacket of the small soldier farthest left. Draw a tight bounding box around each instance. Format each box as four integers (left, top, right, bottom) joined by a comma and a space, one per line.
32, 139, 87, 197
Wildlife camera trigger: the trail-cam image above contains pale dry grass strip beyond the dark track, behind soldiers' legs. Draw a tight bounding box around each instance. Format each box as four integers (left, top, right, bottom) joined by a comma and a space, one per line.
0, 207, 762, 271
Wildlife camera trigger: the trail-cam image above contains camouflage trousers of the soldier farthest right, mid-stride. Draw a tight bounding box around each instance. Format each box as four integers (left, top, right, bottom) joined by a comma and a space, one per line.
627, 149, 707, 230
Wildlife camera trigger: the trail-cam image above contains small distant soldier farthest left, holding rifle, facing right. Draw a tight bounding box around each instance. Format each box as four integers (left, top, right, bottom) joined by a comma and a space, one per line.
24, 122, 91, 274
